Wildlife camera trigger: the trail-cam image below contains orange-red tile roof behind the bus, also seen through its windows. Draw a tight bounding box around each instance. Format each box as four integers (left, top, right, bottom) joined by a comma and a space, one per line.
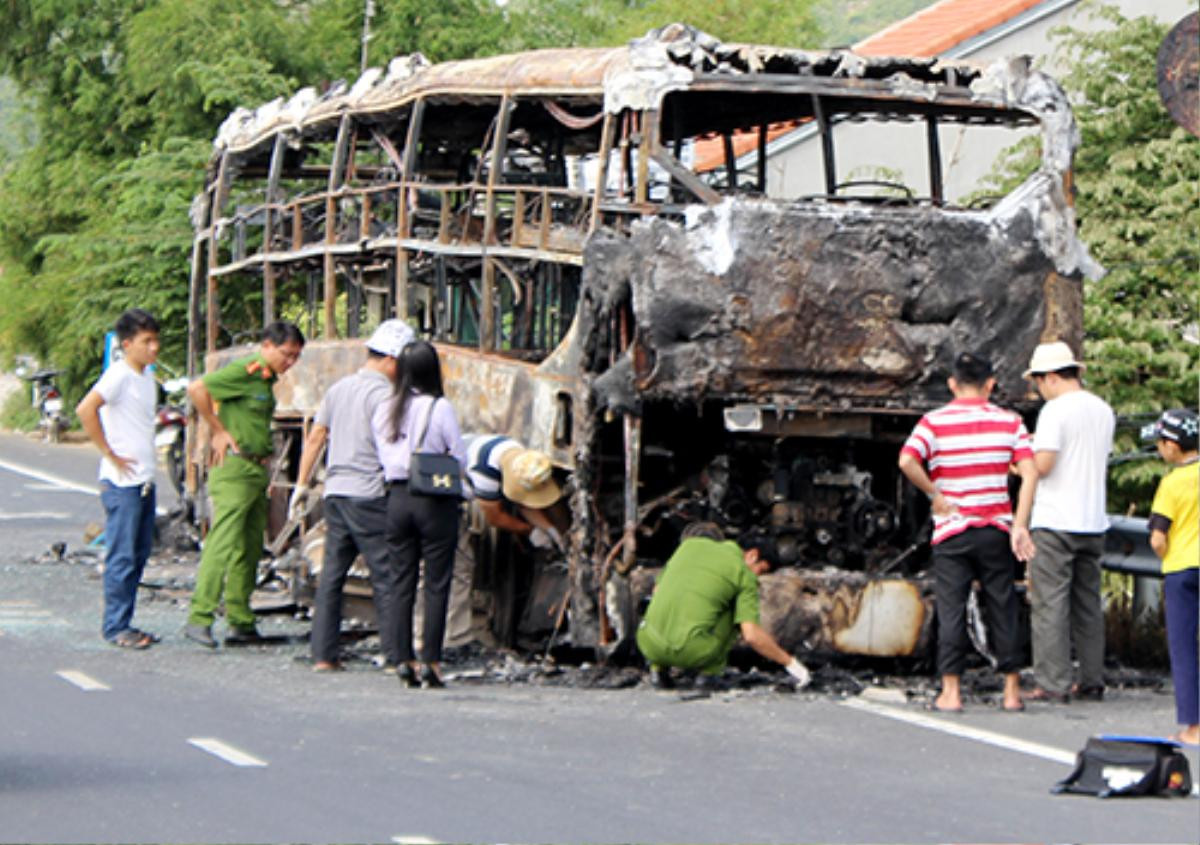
692, 0, 1043, 173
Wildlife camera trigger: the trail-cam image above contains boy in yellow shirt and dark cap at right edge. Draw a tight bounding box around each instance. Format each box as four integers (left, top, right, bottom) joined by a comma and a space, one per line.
1147, 408, 1200, 745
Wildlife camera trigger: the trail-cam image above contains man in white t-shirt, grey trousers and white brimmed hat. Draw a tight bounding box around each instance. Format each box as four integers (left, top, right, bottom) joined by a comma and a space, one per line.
1025, 341, 1116, 703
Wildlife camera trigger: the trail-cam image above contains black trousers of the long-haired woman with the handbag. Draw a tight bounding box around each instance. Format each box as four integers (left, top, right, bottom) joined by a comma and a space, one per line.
388, 483, 461, 663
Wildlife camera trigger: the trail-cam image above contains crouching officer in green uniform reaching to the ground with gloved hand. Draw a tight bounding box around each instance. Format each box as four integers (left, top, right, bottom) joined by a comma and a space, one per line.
637, 526, 809, 689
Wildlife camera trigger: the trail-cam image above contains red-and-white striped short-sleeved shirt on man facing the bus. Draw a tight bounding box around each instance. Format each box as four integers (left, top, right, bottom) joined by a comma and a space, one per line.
900, 398, 1033, 545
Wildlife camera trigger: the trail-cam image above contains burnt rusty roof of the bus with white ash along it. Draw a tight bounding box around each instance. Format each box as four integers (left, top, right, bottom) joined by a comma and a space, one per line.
215, 24, 1041, 166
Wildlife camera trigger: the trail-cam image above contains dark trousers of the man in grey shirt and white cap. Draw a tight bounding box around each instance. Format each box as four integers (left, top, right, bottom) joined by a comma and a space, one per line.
310, 496, 400, 665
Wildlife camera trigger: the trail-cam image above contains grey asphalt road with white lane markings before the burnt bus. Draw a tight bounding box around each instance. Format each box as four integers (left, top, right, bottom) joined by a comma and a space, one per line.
0, 436, 1200, 843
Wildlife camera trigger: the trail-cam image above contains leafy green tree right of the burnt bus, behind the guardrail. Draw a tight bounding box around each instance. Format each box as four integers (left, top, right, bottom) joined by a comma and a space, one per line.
974, 7, 1200, 510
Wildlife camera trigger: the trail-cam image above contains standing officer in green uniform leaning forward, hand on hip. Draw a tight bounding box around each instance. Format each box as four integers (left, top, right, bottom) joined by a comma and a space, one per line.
184, 322, 304, 648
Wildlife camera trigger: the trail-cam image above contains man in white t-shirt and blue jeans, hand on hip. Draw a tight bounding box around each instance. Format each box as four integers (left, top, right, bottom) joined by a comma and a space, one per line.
76, 308, 158, 649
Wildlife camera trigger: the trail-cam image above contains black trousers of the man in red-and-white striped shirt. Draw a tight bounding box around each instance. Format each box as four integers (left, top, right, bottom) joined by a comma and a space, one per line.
934, 527, 1021, 675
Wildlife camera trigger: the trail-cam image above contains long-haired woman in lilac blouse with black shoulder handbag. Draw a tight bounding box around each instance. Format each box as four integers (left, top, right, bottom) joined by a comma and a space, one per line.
373, 341, 466, 689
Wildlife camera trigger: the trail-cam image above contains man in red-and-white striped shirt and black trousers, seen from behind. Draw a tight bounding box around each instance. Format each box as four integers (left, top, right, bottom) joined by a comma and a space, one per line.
900, 353, 1038, 712
